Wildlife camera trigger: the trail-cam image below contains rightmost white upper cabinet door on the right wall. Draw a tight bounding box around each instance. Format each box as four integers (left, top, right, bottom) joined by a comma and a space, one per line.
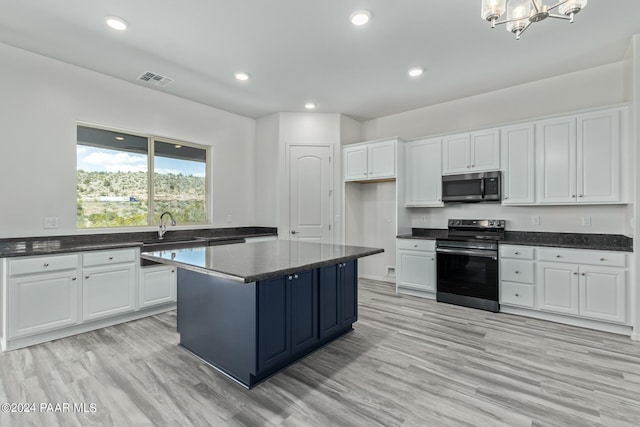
577, 110, 620, 203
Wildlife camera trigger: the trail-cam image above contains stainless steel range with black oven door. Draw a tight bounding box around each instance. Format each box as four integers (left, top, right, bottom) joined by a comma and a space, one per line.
436, 219, 505, 312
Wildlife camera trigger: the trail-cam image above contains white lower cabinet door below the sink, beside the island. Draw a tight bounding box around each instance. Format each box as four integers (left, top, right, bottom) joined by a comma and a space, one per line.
138, 265, 177, 308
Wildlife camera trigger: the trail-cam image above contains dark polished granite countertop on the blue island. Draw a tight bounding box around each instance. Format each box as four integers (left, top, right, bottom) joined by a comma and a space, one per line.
141, 240, 384, 283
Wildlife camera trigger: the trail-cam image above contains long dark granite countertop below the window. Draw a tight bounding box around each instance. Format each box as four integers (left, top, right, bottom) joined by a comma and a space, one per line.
0, 227, 278, 258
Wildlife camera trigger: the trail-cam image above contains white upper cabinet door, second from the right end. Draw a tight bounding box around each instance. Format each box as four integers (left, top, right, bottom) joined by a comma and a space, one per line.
536, 118, 577, 204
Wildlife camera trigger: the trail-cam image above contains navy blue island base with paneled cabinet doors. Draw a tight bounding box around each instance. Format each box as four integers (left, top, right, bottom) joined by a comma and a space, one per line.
178, 260, 358, 388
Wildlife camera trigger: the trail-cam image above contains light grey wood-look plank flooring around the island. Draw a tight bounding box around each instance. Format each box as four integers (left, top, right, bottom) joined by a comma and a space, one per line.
0, 280, 640, 427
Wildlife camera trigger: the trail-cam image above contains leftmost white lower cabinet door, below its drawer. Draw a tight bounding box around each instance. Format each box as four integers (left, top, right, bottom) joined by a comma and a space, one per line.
7, 271, 79, 338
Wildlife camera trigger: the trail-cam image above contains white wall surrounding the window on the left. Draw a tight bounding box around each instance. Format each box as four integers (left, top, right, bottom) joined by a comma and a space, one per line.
0, 44, 255, 241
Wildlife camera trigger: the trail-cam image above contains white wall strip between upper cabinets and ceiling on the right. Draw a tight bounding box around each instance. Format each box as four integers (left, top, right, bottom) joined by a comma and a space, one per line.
362, 61, 624, 140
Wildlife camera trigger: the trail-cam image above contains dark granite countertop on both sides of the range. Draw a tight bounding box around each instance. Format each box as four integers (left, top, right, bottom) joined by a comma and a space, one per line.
397, 228, 633, 252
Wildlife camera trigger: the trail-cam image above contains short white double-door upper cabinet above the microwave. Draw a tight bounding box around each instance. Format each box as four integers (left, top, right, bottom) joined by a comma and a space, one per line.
442, 129, 500, 175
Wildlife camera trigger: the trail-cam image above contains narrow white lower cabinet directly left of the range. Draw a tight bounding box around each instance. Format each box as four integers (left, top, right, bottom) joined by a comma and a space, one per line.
396, 239, 436, 295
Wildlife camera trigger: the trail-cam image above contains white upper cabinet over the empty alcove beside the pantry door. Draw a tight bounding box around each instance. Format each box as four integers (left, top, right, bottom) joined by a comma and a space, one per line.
342, 139, 396, 181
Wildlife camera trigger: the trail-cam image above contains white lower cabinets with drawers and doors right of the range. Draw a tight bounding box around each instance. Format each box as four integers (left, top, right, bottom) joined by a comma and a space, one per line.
500, 245, 630, 325
